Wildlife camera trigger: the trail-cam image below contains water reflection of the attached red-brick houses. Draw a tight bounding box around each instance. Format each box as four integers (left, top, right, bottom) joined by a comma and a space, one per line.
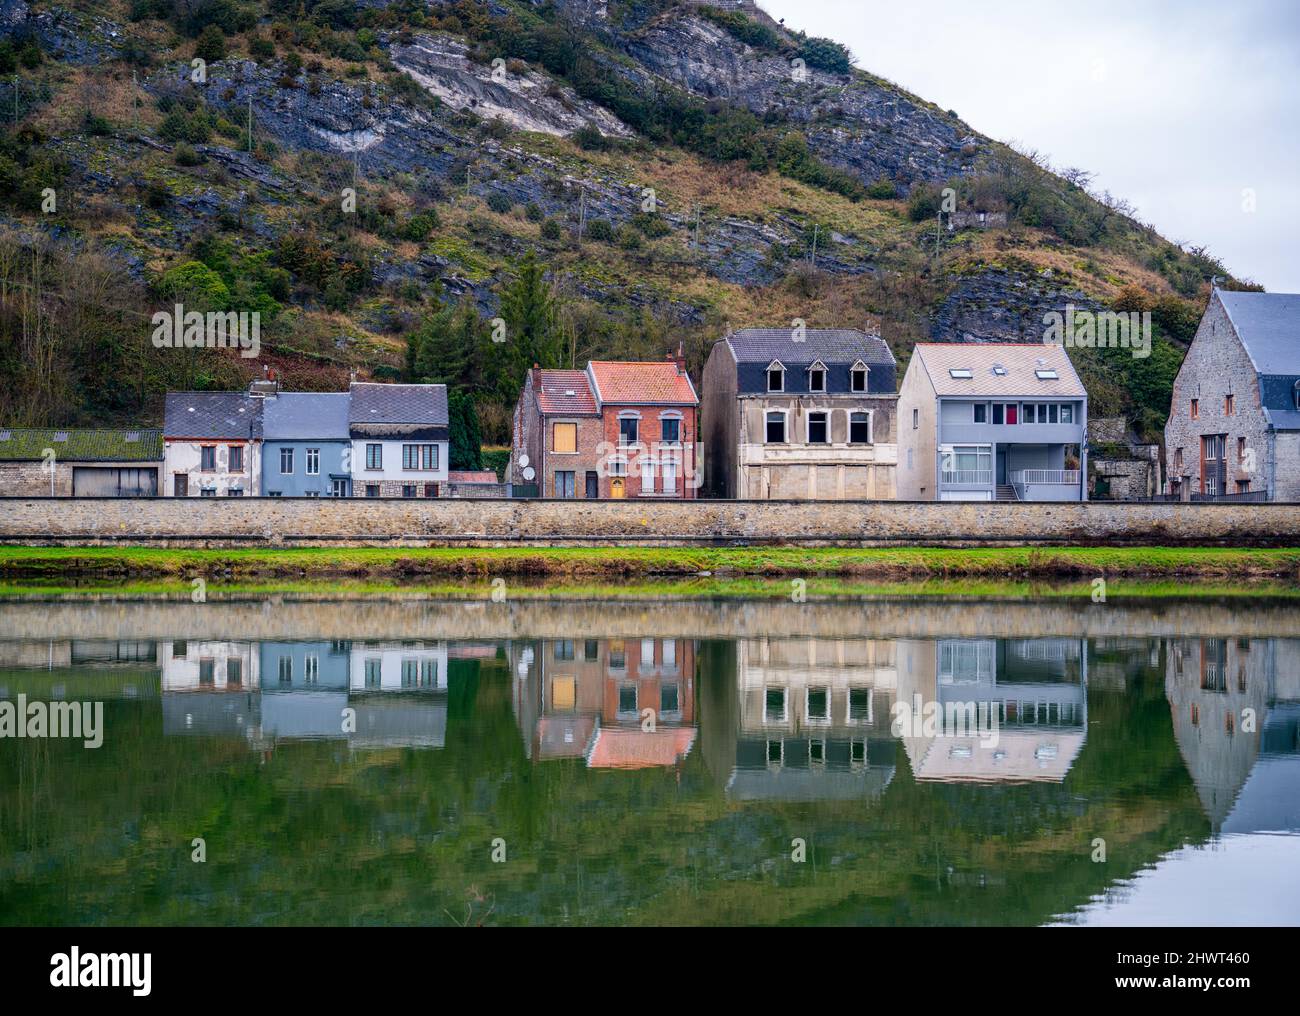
510, 638, 696, 769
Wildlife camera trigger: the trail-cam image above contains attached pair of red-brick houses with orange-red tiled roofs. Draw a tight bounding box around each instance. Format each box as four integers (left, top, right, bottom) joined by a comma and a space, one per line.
510, 357, 699, 499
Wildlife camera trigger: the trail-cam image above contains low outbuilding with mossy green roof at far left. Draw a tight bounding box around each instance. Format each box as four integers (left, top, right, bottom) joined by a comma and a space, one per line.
0, 427, 163, 498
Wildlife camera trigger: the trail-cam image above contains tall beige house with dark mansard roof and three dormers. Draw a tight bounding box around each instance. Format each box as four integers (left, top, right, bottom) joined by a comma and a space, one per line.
701, 329, 898, 500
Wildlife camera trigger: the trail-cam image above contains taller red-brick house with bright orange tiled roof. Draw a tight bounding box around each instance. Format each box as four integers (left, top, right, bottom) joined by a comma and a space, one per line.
586, 356, 703, 499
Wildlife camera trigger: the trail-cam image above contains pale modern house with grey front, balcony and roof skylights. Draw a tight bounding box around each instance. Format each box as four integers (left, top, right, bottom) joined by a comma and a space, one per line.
898, 343, 1088, 502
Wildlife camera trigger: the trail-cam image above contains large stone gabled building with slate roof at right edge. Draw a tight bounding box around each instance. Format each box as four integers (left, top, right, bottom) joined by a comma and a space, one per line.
1165, 288, 1300, 502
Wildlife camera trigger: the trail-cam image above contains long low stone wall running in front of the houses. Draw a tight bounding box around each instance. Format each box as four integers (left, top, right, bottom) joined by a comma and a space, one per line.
0, 498, 1300, 547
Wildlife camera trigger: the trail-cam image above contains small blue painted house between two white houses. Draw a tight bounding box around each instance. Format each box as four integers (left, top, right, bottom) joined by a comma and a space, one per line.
261, 391, 352, 498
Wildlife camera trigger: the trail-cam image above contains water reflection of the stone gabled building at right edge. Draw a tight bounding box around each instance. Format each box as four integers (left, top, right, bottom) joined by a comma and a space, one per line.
1165, 638, 1300, 833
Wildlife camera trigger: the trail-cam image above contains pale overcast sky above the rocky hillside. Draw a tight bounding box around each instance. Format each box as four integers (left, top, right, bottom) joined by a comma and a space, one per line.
759, 0, 1300, 292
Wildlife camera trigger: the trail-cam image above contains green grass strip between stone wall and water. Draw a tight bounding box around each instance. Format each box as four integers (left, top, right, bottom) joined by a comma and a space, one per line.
0, 547, 1300, 585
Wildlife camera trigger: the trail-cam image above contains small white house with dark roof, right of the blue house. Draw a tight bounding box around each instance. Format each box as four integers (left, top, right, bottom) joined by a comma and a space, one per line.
348, 382, 451, 498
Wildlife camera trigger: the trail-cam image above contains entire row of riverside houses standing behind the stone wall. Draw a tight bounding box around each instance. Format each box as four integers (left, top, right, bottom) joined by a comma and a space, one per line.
0, 288, 1300, 502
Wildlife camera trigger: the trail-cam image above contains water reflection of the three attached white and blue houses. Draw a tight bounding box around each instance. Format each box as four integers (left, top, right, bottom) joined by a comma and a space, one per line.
159, 641, 447, 748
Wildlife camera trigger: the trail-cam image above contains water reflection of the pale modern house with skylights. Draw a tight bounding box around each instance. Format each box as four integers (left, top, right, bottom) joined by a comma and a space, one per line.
898, 638, 1088, 782
